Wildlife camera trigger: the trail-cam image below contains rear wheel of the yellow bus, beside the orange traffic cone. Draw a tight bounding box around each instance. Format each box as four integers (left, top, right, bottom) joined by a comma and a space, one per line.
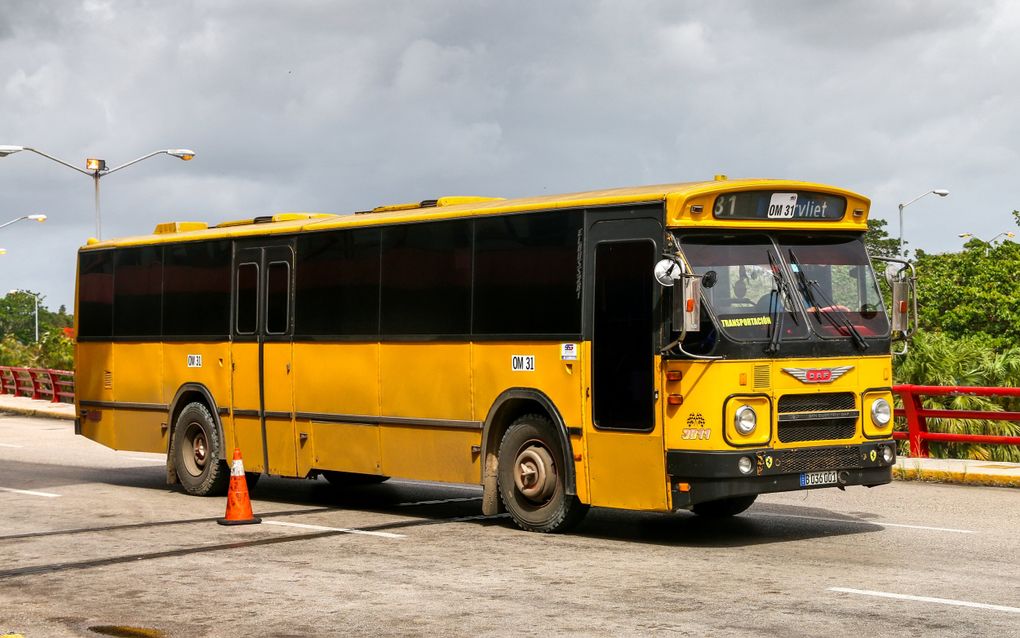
172, 402, 231, 496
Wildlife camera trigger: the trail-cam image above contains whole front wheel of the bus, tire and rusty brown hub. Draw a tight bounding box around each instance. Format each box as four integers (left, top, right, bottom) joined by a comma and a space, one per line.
497, 414, 588, 533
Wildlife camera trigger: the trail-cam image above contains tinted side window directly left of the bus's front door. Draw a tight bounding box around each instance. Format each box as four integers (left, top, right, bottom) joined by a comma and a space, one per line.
472, 211, 582, 335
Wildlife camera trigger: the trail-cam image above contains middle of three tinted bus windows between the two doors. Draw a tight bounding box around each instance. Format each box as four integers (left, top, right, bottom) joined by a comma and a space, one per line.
381, 219, 471, 335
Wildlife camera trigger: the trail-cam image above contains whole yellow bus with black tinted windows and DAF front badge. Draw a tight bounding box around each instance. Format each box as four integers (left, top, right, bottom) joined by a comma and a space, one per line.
74, 176, 910, 532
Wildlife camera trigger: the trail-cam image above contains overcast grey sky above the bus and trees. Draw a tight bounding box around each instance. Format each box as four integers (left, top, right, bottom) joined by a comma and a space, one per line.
0, 0, 1020, 308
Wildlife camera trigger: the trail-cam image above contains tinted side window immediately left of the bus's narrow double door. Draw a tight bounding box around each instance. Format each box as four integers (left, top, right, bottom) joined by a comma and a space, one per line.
163, 240, 231, 338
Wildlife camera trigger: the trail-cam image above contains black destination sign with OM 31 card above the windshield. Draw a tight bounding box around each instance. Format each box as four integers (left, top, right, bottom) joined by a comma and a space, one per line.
712, 191, 847, 222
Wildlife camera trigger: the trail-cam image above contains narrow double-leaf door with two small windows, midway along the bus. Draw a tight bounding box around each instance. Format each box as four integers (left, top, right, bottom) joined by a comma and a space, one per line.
232, 242, 299, 476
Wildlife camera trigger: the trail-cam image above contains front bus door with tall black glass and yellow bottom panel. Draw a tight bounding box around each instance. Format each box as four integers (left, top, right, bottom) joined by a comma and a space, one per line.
584, 215, 668, 510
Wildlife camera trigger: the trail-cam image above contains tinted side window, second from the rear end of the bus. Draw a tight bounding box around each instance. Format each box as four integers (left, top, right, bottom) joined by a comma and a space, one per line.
113, 246, 163, 337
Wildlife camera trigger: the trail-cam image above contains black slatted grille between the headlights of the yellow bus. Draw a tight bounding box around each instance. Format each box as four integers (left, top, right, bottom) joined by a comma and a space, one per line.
777, 392, 858, 443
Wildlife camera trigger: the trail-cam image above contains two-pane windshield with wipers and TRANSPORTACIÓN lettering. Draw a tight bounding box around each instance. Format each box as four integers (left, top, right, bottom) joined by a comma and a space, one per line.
680, 233, 888, 343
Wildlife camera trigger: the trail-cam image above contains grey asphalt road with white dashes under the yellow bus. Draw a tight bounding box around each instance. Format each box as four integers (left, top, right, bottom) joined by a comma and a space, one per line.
0, 415, 1020, 637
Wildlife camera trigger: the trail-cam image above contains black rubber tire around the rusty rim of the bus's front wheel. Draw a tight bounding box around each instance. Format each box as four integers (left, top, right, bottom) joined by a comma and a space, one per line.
497, 414, 588, 533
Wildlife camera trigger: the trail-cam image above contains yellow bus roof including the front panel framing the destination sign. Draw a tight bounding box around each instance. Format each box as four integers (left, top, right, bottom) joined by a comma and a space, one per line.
83, 176, 871, 249
